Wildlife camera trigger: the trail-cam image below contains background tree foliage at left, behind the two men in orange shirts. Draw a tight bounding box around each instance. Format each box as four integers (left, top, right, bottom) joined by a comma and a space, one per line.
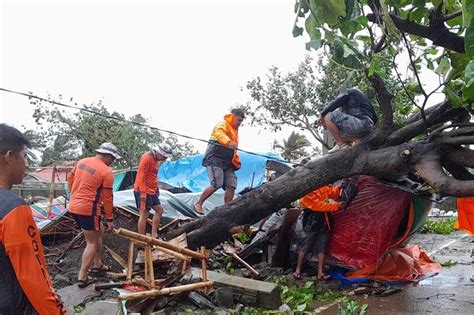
31, 97, 196, 168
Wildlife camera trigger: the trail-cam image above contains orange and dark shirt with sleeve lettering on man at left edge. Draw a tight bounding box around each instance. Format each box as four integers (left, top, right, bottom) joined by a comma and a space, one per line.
0, 189, 67, 315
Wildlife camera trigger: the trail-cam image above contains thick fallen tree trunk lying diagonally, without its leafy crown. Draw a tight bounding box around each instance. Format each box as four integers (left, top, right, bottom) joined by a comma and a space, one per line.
169, 137, 474, 248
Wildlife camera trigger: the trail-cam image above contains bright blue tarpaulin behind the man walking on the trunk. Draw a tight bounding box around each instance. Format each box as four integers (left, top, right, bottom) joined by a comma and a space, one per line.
158, 152, 282, 192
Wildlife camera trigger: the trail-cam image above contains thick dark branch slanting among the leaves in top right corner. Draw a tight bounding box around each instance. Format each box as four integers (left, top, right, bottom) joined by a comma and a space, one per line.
367, 13, 466, 53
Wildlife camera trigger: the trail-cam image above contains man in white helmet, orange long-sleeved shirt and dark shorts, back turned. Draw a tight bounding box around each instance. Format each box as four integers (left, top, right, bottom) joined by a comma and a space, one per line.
68, 142, 120, 288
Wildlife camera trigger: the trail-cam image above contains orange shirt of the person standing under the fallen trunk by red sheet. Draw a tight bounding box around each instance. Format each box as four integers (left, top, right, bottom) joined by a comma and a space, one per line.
300, 186, 341, 212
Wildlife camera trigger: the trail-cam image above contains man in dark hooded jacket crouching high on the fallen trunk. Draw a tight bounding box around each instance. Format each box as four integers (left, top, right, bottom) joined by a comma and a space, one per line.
316, 88, 377, 153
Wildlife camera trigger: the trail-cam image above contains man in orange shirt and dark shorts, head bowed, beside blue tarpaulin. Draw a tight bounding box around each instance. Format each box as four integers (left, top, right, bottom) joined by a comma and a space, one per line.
133, 146, 172, 238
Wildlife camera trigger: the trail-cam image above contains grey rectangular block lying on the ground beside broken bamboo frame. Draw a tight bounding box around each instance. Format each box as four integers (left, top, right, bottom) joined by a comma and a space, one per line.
190, 267, 281, 309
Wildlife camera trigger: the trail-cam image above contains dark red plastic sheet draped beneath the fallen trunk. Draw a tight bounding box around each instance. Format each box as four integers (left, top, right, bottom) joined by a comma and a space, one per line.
327, 176, 411, 269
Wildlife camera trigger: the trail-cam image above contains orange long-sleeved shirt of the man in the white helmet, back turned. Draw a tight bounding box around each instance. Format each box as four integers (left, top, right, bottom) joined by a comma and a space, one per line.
68, 157, 114, 220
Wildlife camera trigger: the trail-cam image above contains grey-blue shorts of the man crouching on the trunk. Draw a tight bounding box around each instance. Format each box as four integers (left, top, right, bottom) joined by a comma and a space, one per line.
327, 110, 374, 138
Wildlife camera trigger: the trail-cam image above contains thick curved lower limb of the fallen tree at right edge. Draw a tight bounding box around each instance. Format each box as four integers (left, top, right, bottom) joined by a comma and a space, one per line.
415, 160, 474, 197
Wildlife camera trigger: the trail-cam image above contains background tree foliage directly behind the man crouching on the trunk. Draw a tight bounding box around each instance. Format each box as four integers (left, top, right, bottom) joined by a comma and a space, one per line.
247, 53, 413, 146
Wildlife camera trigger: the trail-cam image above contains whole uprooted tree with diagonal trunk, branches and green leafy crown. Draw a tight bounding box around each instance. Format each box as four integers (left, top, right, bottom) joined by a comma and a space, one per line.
168, 0, 474, 248
